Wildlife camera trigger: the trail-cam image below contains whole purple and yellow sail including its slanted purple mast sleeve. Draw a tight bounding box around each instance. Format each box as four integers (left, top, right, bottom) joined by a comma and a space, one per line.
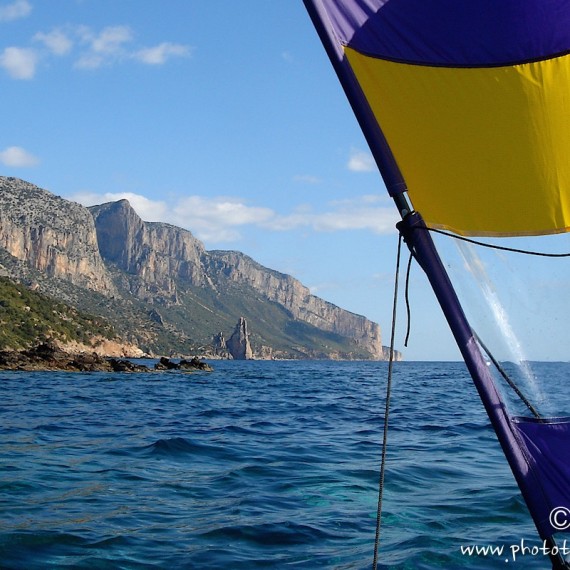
304, 0, 570, 568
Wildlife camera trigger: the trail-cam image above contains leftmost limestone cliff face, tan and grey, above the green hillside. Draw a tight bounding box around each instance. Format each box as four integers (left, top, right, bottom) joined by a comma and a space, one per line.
0, 176, 115, 294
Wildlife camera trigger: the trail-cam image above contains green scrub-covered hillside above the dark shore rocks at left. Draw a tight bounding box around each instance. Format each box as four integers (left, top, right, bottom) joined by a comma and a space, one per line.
0, 277, 116, 350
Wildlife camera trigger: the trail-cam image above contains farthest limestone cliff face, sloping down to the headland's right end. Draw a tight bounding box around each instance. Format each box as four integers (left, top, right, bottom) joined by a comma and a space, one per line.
204, 251, 385, 360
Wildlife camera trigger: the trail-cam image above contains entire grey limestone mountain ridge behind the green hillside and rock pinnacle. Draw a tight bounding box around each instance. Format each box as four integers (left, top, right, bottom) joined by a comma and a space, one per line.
0, 177, 394, 360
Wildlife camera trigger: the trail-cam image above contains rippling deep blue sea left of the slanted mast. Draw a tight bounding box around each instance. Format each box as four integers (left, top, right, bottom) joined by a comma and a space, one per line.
0, 361, 570, 570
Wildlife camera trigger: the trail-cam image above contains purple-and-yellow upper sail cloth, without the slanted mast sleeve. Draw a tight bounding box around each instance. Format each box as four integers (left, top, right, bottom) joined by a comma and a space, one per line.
304, 0, 570, 236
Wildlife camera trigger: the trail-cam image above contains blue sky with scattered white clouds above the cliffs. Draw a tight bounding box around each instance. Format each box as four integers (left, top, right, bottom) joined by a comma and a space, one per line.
0, 0, 566, 360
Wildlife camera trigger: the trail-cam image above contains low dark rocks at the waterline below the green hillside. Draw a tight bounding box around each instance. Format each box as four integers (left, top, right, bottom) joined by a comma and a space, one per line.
0, 342, 212, 372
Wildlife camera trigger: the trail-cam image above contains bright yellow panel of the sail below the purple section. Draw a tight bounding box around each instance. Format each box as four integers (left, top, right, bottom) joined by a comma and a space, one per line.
345, 48, 570, 236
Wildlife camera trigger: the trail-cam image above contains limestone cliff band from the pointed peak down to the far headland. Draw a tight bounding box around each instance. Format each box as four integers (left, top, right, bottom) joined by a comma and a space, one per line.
90, 200, 384, 360
